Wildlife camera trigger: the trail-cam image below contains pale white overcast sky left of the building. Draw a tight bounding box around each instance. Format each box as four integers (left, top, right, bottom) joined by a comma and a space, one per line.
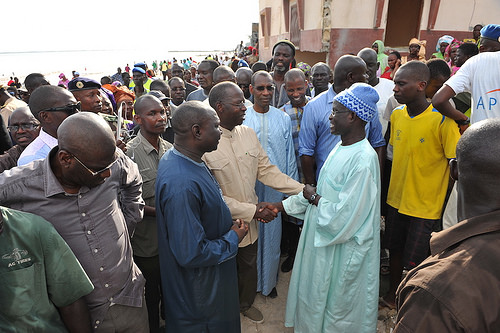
5, 0, 259, 52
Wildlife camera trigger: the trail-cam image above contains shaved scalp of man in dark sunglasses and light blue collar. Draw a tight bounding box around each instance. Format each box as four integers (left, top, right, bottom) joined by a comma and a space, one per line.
28, 85, 76, 120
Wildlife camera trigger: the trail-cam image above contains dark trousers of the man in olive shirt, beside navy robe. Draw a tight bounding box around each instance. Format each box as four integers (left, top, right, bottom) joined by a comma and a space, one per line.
134, 256, 162, 333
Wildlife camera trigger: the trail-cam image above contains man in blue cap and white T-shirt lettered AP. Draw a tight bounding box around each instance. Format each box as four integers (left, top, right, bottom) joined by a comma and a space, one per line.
432, 24, 500, 124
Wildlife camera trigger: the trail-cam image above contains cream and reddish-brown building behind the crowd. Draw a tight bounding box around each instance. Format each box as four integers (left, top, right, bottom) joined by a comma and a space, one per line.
259, 0, 500, 66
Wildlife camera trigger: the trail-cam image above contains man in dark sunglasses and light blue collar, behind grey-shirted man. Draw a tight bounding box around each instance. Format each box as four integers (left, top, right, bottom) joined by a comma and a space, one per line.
17, 85, 81, 166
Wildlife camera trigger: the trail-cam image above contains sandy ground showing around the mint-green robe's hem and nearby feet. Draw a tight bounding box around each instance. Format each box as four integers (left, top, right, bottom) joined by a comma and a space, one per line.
240, 258, 396, 333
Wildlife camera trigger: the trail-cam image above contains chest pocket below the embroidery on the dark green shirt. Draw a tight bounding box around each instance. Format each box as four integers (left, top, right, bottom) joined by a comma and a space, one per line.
0, 263, 42, 318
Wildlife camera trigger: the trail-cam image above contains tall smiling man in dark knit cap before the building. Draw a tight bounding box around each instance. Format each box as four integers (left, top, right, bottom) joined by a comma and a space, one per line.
271, 39, 295, 108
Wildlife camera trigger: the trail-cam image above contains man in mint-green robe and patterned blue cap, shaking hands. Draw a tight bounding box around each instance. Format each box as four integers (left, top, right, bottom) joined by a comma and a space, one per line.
274, 83, 380, 333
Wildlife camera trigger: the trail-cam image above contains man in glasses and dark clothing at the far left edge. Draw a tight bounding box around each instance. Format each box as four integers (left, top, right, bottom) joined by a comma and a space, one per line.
0, 106, 40, 173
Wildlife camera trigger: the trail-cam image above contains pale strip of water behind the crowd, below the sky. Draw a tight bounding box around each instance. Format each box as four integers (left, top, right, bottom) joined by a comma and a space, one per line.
0, 49, 231, 84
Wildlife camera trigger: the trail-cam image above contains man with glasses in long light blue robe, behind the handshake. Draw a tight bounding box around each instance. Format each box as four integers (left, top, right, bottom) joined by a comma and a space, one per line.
243, 71, 299, 298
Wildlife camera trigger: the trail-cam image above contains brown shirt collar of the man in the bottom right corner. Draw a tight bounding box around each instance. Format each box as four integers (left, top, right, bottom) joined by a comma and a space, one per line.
431, 210, 500, 255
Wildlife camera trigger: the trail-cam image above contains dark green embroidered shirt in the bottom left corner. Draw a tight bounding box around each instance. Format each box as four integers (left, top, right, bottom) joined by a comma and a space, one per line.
0, 207, 94, 332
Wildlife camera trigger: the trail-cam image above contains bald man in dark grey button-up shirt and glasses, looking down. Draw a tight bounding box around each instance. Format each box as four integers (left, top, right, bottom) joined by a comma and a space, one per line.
0, 112, 149, 333
